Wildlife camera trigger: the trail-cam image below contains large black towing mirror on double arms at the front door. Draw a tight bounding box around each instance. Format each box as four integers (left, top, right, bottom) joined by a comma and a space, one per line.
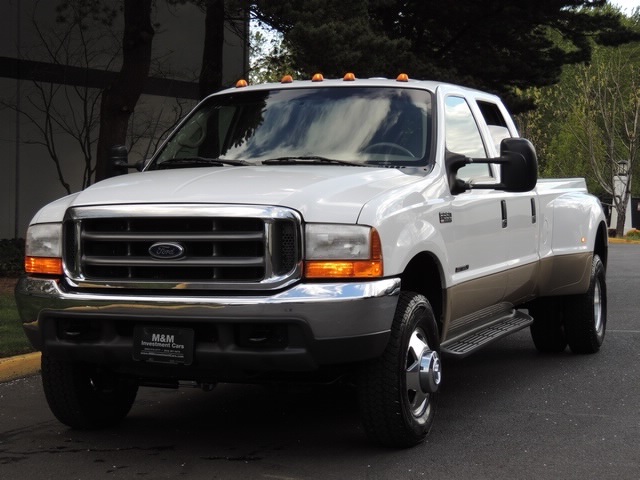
446, 138, 538, 195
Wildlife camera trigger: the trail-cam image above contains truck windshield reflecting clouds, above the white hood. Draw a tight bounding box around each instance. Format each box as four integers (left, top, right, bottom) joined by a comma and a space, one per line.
149, 87, 431, 170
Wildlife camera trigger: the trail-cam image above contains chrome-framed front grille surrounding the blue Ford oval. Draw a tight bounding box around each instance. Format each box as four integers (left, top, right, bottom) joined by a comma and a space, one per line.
64, 205, 301, 289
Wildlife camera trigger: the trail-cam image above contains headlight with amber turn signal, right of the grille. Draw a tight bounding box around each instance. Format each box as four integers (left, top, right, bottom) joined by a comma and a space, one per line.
304, 224, 383, 278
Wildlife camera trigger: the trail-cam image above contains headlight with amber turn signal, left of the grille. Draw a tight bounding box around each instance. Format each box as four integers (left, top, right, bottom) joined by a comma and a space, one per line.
24, 223, 62, 275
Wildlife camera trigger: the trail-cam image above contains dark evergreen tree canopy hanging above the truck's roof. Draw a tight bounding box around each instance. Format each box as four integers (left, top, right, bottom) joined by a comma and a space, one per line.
255, 0, 637, 112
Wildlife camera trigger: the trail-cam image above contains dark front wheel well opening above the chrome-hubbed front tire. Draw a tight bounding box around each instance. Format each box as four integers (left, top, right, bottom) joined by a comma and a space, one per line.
400, 252, 444, 331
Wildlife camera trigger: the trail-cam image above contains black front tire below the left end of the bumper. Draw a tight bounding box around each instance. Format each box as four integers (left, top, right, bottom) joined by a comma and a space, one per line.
42, 354, 138, 430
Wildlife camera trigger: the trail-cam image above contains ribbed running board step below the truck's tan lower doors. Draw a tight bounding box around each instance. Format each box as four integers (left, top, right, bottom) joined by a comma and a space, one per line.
440, 310, 533, 357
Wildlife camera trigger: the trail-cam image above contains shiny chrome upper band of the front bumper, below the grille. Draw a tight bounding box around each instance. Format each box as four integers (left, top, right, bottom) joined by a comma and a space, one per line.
16, 276, 400, 339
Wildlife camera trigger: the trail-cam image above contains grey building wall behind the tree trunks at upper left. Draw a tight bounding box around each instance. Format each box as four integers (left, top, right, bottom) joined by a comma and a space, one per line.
0, 0, 248, 238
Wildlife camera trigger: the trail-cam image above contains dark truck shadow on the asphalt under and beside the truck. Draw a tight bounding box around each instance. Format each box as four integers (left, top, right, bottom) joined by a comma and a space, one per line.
52, 332, 608, 461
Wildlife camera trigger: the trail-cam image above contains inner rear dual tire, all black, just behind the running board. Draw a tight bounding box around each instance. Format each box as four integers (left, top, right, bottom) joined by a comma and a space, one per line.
529, 297, 567, 353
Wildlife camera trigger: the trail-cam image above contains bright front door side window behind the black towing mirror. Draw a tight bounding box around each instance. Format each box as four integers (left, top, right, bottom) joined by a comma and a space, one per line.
444, 97, 491, 180
